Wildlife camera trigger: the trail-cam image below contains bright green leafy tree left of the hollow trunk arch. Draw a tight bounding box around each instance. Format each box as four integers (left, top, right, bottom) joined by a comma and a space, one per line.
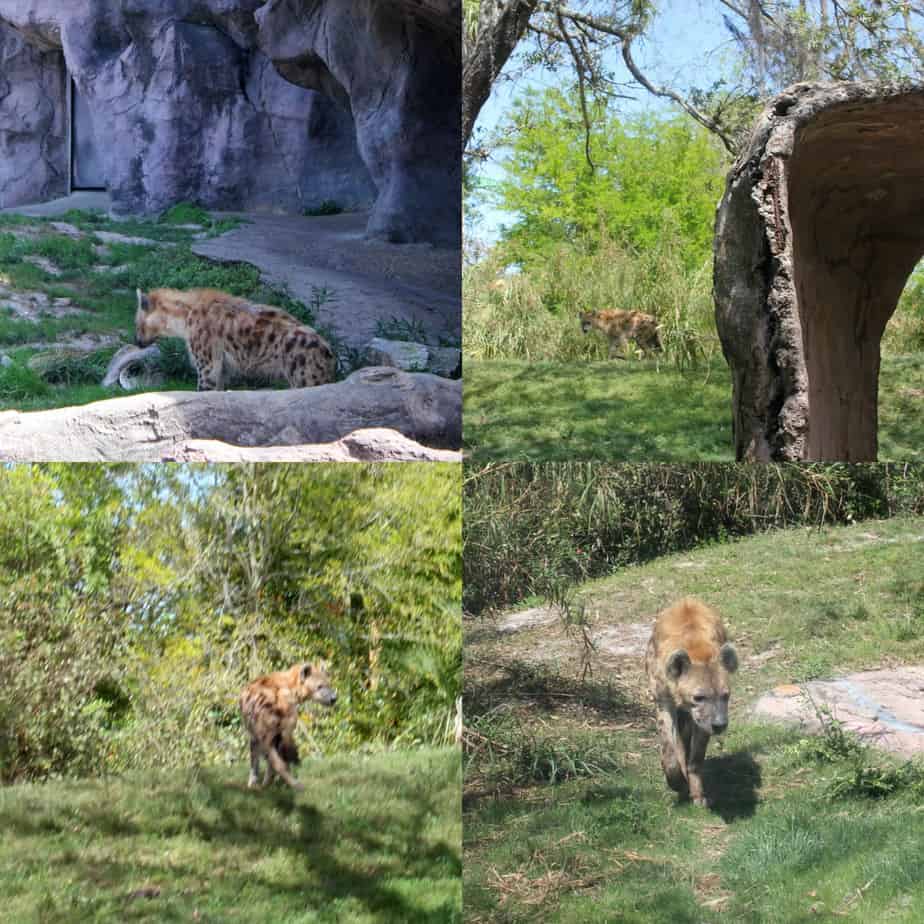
498, 89, 725, 268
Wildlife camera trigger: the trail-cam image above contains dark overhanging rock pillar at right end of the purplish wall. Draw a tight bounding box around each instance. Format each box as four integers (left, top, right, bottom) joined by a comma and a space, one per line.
256, 0, 462, 244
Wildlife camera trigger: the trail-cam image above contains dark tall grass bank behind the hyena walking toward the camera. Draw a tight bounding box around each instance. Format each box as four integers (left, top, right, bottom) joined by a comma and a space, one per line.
463, 462, 924, 614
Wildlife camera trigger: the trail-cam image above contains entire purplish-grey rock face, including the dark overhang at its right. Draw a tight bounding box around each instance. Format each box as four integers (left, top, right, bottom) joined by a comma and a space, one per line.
0, 0, 461, 243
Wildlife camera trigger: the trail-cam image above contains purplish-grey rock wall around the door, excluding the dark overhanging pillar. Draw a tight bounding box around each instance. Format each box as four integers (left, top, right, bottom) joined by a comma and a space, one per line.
0, 0, 375, 214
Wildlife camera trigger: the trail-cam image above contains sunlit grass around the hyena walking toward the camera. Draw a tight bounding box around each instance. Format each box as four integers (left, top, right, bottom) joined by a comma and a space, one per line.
464, 519, 924, 924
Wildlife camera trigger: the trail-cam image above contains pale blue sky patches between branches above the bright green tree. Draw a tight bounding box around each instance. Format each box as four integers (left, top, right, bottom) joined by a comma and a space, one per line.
474, 0, 733, 242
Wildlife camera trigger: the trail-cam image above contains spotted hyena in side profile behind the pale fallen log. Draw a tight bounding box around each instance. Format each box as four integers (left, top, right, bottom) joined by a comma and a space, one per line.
135, 289, 337, 391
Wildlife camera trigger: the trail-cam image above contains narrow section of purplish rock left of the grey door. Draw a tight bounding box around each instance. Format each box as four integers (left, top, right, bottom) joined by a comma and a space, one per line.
0, 23, 69, 208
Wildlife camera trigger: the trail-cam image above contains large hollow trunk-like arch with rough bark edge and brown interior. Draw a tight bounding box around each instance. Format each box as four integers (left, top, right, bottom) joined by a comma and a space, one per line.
714, 83, 924, 461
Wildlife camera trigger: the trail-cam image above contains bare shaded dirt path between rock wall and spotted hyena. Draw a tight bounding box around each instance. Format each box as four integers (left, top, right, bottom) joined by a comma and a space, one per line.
193, 212, 462, 348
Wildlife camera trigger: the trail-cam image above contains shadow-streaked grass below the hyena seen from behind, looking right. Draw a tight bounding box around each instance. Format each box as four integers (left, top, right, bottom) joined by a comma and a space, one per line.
0, 771, 462, 924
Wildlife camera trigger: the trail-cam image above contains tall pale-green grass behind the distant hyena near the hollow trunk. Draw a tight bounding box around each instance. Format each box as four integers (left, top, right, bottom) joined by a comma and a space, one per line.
462, 239, 719, 366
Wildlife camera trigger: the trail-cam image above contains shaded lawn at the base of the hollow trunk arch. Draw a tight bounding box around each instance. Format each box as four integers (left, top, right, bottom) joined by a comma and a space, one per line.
464, 355, 924, 462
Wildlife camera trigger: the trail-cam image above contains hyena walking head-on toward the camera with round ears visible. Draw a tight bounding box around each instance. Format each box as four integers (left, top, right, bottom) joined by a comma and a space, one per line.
645, 597, 738, 805
